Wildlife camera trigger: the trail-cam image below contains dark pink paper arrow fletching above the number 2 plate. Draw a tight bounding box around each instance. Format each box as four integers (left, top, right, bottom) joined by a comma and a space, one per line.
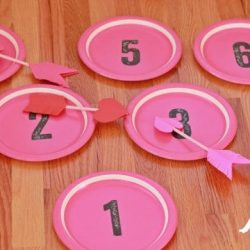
29, 62, 78, 88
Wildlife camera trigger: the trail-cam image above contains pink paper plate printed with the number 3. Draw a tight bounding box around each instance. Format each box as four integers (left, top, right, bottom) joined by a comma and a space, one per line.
125, 83, 237, 160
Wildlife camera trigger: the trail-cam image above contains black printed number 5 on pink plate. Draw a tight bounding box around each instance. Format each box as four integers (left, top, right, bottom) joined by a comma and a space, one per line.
122, 40, 140, 66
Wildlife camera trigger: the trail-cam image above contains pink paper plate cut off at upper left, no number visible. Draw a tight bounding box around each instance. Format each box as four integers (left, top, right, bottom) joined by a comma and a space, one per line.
0, 25, 25, 81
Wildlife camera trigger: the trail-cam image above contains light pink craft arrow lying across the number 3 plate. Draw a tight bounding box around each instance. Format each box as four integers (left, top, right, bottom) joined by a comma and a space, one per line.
154, 117, 250, 180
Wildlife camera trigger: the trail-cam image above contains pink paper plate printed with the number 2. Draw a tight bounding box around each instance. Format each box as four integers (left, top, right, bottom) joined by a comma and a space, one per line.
0, 84, 95, 161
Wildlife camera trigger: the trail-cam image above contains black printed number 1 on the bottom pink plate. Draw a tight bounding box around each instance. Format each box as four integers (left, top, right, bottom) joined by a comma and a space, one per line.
103, 200, 122, 236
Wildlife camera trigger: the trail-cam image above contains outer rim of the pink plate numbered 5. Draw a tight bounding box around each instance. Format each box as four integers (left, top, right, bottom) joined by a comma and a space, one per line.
77, 16, 182, 82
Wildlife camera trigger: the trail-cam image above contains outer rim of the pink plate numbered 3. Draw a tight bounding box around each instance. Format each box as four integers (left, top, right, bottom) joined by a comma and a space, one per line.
124, 83, 238, 161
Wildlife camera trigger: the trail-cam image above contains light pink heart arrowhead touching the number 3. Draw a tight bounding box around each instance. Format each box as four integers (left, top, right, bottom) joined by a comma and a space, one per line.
154, 116, 183, 133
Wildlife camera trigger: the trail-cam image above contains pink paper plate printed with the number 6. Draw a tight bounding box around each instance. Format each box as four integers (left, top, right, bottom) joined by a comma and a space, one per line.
193, 19, 250, 84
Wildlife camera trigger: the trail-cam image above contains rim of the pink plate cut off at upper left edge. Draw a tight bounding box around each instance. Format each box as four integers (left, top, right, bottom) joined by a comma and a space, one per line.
0, 25, 26, 82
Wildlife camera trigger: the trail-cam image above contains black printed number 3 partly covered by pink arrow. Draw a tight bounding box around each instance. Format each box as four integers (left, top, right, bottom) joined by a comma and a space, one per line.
169, 109, 192, 139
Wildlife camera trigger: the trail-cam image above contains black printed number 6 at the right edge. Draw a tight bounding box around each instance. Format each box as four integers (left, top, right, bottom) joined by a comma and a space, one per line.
233, 42, 250, 68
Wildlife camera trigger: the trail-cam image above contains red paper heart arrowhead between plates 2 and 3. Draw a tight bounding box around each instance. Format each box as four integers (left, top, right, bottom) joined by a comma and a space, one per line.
94, 98, 128, 123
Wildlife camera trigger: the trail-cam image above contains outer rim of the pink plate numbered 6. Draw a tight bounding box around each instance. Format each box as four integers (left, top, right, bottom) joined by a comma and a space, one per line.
193, 19, 250, 85
